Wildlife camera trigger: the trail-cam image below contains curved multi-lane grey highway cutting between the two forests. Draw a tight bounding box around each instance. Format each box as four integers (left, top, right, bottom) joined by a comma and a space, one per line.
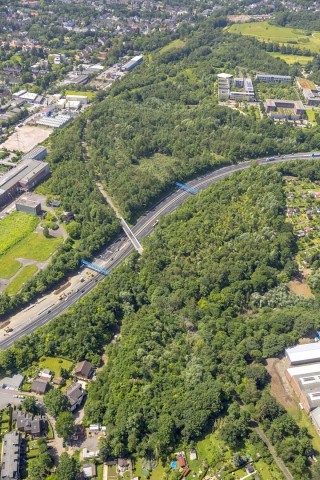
0, 152, 320, 350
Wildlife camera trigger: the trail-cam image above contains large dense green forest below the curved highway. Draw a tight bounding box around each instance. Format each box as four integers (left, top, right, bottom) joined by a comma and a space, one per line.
0, 161, 320, 479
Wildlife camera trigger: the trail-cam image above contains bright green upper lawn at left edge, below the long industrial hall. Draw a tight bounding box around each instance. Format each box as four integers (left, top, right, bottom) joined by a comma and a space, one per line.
0, 212, 39, 255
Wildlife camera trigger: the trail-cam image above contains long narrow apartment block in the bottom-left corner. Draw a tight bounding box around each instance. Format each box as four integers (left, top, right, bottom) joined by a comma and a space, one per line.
0, 431, 21, 480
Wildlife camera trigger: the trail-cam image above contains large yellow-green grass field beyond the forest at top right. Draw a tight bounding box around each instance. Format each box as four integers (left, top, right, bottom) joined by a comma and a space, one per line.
228, 22, 320, 53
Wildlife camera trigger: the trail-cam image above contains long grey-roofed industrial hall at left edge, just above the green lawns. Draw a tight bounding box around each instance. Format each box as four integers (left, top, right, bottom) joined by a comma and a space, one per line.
0, 159, 50, 205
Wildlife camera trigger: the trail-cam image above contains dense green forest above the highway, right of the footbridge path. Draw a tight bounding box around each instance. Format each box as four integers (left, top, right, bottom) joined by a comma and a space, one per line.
85, 21, 320, 221
